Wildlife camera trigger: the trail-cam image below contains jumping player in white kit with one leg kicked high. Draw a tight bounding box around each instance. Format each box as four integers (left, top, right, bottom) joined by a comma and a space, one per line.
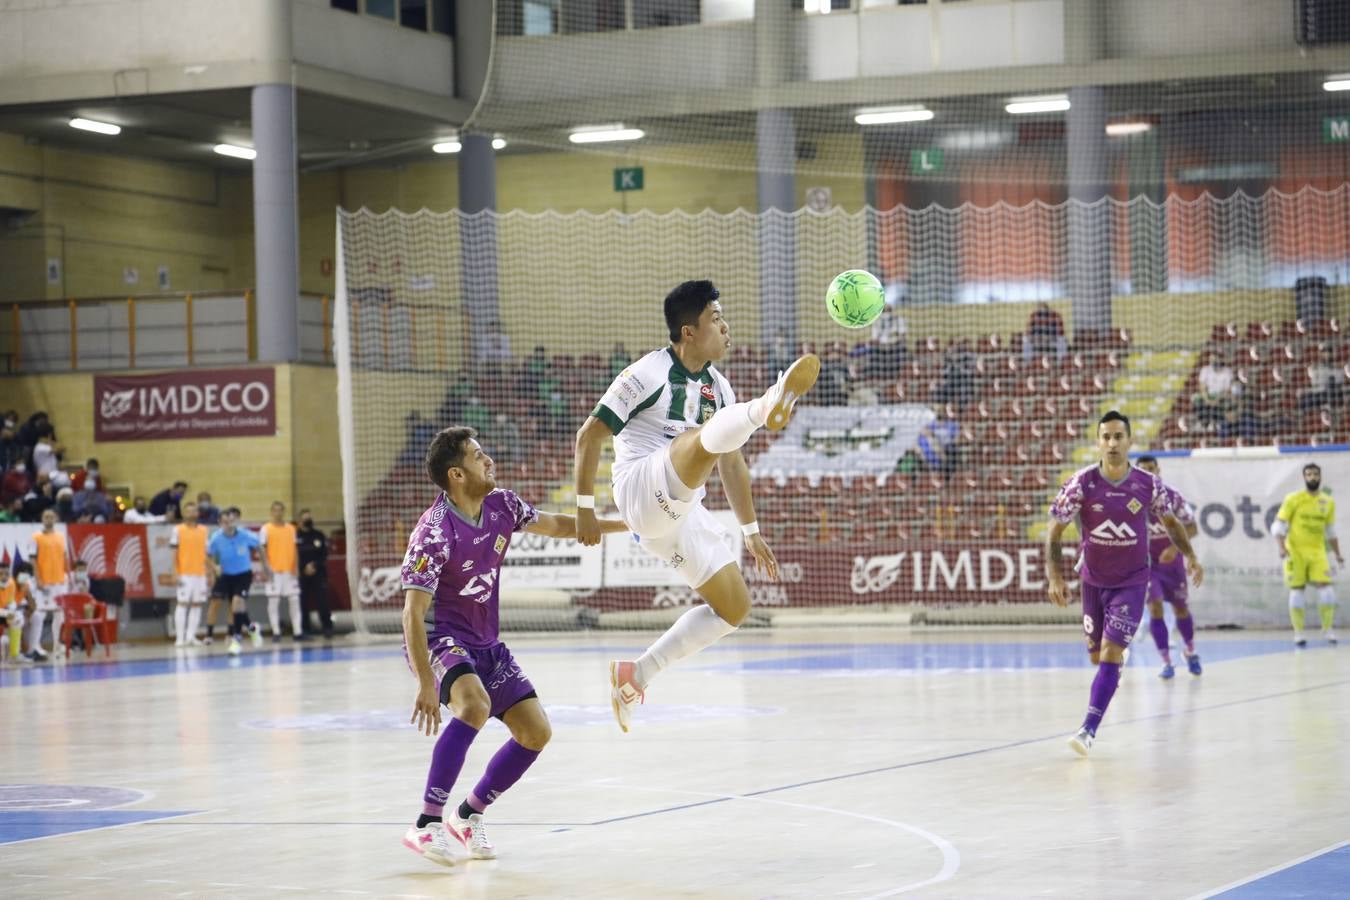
576, 281, 821, 731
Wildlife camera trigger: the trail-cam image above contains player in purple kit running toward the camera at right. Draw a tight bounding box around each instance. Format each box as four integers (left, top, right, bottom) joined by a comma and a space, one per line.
1045, 409, 1204, 756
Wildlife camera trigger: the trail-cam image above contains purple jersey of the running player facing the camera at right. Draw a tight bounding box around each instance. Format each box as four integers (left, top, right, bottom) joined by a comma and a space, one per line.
1050, 466, 1172, 588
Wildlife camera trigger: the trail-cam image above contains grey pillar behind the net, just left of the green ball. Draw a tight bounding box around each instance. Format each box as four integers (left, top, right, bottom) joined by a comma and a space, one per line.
755, 0, 798, 347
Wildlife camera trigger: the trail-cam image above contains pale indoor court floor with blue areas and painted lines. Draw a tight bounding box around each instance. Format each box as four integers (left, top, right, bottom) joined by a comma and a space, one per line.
0, 627, 1350, 899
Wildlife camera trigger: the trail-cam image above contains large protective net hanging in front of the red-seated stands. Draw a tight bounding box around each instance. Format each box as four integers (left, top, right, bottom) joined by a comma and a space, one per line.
335, 186, 1350, 631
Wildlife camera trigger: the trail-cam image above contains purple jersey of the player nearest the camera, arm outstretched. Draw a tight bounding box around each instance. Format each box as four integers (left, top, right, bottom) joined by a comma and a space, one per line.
402, 491, 539, 650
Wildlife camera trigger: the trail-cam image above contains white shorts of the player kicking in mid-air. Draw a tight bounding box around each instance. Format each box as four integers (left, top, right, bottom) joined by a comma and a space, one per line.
614, 453, 737, 588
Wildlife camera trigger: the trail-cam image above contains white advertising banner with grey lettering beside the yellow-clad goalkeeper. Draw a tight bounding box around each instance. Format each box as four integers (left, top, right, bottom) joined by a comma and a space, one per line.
1158, 449, 1350, 626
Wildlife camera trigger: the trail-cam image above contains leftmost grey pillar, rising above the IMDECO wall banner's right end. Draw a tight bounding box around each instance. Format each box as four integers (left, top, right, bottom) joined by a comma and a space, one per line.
252, 84, 300, 363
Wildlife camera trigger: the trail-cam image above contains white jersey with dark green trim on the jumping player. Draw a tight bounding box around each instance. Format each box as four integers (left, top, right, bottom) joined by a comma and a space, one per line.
591, 347, 736, 483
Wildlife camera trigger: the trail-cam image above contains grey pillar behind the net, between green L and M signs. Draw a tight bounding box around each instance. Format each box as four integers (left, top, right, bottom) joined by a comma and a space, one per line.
1065, 86, 1112, 333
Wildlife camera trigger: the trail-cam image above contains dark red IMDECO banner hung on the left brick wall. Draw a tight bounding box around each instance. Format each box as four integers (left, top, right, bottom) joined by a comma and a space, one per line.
93, 368, 277, 441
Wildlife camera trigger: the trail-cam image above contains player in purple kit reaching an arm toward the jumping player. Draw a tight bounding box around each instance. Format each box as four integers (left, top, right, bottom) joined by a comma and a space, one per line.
402, 426, 628, 865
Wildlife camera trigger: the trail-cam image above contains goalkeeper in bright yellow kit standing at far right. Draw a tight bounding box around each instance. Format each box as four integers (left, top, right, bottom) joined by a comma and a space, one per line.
1272, 463, 1346, 646
